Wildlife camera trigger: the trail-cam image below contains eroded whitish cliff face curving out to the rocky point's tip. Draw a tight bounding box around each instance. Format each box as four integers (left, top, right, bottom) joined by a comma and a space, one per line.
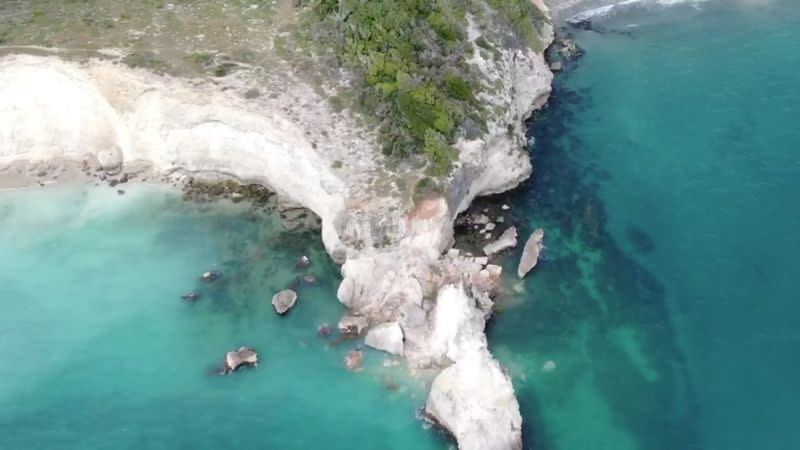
0, 1, 552, 449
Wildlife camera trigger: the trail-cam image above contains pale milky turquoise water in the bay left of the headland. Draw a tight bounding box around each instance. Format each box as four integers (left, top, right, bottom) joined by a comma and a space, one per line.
0, 186, 446, 450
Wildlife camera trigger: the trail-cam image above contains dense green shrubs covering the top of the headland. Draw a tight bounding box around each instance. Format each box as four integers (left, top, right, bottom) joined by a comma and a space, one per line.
308, 0, 543, 176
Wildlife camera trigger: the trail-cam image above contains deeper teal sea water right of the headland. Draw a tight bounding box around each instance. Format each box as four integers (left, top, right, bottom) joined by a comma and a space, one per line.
490, 1, 800, 450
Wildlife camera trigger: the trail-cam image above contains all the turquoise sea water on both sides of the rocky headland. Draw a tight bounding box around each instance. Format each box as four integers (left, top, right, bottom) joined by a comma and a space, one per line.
0, 1, 800, 450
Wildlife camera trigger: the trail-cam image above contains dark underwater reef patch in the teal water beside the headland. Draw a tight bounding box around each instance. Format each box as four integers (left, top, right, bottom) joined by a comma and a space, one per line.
467, 67, 698, 450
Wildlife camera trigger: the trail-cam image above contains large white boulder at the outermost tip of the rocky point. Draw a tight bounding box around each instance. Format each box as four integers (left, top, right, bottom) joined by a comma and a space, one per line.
425, 349, 522, 450
